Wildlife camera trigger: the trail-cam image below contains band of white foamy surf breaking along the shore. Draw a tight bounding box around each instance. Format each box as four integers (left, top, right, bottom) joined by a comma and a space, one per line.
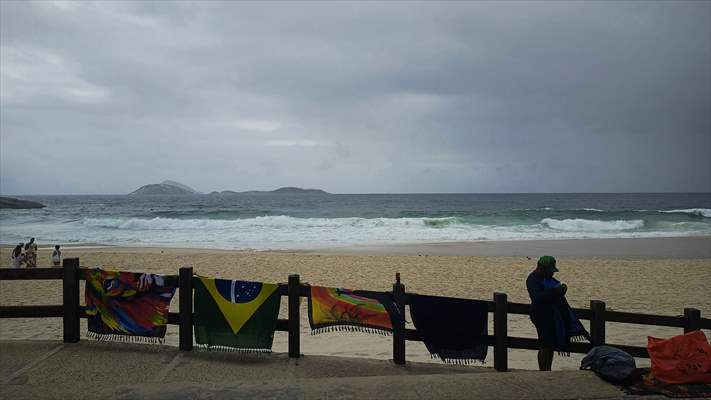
0, 215, 711, 249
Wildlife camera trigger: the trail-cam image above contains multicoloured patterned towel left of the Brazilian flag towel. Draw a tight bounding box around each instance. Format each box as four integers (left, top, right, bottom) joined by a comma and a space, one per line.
84, 268, 176, 343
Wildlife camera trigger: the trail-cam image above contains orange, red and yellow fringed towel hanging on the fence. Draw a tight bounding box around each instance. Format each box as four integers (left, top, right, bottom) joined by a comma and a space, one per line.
309, 286, 396, 335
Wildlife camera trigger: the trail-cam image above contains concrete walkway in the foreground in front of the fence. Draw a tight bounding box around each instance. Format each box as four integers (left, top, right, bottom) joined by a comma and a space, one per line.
0, 341, 663, 400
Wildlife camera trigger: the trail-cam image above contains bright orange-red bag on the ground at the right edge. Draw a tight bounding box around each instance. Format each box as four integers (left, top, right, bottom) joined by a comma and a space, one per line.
647, 331, 711, 384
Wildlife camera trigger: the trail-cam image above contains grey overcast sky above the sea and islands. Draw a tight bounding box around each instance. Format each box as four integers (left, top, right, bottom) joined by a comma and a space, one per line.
0, 1, 711, 194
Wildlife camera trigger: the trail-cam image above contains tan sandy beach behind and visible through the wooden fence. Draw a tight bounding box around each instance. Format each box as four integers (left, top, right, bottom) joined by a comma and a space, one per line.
0, 237, 711, 369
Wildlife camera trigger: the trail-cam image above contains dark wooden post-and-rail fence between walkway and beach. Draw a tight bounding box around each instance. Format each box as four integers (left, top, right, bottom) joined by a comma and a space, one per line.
0, 258, 711, 371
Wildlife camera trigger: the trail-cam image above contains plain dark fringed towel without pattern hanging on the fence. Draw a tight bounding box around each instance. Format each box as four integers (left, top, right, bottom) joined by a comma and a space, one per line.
409, 294, 488, 364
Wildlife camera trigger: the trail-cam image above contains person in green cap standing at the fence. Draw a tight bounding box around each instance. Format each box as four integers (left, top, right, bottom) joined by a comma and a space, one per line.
526, 256, 568, 371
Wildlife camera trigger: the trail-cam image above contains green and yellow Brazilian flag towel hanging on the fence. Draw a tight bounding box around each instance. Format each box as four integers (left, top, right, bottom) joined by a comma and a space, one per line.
193, 277, 281, 353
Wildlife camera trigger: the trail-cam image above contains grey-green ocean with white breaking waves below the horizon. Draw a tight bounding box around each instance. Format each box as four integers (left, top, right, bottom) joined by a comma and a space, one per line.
0, 193, 711, 250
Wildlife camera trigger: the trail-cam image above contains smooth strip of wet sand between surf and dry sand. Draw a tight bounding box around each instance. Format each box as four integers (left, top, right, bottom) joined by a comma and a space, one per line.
0, 236, 711, 260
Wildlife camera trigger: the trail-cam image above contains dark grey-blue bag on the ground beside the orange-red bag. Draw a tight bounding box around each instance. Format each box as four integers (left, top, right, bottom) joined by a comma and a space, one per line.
580, 345, 637, 383
